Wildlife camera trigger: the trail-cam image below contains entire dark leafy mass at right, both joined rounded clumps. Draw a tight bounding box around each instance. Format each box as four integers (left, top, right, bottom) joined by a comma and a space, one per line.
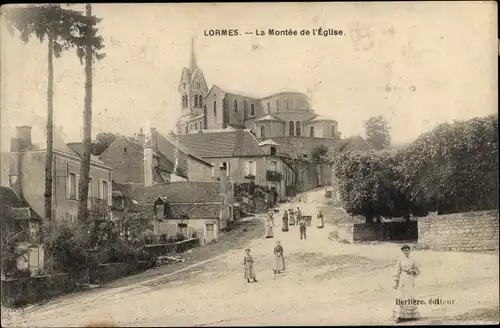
333, 115, 498, 222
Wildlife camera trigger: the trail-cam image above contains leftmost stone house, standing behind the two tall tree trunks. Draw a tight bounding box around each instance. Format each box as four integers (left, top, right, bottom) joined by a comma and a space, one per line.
1, 126, 112, 220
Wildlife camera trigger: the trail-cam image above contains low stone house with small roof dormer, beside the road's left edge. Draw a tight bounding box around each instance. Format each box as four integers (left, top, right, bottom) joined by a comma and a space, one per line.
130, 167, 234, 245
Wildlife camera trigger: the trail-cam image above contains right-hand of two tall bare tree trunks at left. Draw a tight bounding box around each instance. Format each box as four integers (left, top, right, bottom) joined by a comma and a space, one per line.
78, 3, 92, 226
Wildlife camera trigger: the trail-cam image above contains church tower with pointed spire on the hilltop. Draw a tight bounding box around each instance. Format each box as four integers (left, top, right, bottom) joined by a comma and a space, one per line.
177, 38, 208, 134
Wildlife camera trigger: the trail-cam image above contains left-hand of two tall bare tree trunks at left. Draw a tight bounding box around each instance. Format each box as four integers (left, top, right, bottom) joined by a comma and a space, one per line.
44, 35, 54, 221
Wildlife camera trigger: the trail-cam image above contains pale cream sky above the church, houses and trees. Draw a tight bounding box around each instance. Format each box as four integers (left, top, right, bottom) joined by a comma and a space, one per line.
0, 1, 498, 151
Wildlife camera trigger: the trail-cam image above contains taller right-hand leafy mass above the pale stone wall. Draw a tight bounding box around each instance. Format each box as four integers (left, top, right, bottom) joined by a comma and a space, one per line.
400, 114, 498, 213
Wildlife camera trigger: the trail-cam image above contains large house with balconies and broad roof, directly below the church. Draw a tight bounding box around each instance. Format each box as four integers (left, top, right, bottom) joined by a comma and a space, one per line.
176, 130, 295, 198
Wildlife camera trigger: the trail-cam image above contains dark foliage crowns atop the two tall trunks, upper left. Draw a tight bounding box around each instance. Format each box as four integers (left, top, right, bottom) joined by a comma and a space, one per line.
6, 4, 105, 64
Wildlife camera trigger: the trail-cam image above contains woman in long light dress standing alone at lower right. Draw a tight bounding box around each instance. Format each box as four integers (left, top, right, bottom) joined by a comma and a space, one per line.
392, 245, 420, 322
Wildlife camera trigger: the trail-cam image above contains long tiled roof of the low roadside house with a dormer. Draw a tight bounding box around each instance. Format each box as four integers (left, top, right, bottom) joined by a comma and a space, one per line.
130, 181, 222, 204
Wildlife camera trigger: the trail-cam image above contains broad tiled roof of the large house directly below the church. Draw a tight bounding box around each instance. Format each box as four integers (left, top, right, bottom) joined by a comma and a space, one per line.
178, 130, 265, 158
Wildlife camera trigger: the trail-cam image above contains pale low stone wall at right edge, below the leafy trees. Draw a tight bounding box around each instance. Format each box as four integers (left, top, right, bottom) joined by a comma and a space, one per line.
417, 211, 499, 252
